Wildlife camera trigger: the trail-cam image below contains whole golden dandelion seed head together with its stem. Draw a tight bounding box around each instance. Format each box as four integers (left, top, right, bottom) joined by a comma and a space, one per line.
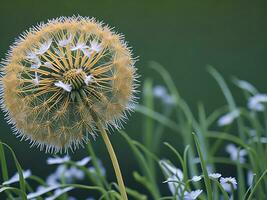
1, 17, 137, 199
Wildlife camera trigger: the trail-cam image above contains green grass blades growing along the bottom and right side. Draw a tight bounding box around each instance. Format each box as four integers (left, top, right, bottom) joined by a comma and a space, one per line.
0, 62, 267, 200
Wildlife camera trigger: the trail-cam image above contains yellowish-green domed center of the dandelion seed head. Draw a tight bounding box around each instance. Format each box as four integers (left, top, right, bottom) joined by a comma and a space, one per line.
63, 69, 86, 90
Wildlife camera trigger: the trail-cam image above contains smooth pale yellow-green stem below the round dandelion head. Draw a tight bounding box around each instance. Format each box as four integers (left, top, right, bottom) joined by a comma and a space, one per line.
97, 122, 128, 200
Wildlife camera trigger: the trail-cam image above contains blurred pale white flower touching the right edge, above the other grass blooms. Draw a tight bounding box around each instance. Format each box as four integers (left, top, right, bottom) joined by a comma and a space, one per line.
248, 94, 267, 111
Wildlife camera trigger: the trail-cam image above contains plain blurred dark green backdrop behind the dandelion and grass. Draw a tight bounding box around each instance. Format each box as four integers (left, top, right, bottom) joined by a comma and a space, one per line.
0, 0, 267, 197
